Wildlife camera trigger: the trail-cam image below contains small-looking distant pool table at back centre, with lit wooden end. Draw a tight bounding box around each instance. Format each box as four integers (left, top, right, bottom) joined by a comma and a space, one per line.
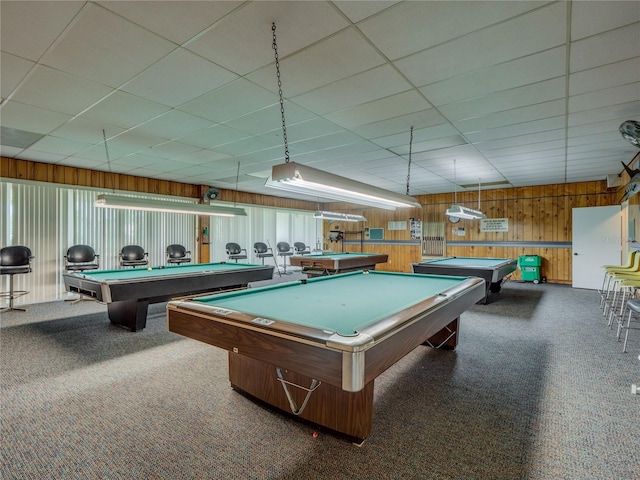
290, 252, 389, 277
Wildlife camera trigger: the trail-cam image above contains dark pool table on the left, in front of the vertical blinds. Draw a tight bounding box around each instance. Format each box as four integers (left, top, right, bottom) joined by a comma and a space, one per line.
62, 262, 274, 332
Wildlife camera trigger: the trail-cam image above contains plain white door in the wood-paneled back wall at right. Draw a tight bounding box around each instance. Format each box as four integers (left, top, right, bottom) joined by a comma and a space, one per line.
572, 205, 622, 290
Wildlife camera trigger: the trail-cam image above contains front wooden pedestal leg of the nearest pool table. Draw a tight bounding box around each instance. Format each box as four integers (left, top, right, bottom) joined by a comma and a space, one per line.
229, 352, 373, 443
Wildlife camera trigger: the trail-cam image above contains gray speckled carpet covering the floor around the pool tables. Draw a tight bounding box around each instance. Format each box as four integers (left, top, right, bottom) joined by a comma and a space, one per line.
0, 280, 640, 480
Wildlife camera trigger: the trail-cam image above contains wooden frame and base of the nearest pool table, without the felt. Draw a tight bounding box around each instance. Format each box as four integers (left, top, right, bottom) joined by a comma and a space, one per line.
167, 272, 484, 443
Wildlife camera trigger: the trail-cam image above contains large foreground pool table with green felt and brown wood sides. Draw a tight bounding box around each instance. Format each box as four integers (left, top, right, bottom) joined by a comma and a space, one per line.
167, 270, 484, 442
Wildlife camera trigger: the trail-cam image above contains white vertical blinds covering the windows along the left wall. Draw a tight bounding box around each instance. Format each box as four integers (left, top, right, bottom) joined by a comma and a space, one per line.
0, 181, 322, 304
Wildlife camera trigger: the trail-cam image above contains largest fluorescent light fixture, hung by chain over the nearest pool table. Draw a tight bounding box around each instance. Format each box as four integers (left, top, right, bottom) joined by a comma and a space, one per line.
265, 162, 421, 210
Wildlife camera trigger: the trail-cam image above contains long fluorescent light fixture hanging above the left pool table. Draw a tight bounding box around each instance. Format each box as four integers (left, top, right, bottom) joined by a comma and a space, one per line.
95, 194, 247, 217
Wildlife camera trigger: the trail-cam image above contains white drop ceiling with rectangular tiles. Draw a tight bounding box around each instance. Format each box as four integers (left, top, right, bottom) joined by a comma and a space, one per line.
0, 0, 640, 200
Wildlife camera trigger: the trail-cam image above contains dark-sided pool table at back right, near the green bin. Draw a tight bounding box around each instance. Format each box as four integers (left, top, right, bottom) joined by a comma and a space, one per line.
412, 257, 518, 304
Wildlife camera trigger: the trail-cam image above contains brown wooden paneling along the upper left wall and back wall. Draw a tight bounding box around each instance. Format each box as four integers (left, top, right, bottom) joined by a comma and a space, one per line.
0, 157, 620, 283
